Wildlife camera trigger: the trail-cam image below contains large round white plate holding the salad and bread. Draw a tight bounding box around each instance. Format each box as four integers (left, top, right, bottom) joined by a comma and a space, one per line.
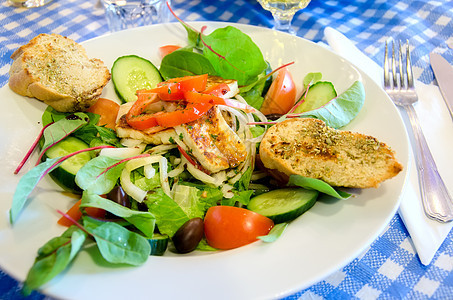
0, 22, 408, 299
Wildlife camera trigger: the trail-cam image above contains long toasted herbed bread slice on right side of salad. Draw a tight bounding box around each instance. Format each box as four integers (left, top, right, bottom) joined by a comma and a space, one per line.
259, 118, 403, 188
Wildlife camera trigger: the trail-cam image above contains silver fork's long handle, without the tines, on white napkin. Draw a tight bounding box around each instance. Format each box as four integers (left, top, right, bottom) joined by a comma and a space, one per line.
404, 105, 453, 222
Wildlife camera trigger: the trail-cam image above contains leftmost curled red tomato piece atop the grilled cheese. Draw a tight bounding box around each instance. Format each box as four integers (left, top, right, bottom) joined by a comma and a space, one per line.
126, 91, 159, 130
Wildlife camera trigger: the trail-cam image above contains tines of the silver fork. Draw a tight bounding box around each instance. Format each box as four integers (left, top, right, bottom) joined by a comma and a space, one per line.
384, 40, 414, 89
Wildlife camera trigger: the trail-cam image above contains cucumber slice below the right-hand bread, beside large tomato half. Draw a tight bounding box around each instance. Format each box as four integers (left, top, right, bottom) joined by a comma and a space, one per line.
247, 188, 319, 224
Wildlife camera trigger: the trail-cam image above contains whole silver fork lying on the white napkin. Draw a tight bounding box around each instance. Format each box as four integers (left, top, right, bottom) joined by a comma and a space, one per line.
384, 41, 453, 222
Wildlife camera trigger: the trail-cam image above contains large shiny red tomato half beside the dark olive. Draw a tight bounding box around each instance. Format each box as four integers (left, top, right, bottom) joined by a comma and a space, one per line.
204, 206, 274, 250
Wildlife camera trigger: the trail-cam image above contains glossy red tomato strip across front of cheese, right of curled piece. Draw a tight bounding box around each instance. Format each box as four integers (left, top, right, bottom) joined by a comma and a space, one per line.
154, 103, 212, 127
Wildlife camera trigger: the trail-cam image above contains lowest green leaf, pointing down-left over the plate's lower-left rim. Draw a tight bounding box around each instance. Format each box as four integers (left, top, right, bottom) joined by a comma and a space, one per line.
23, 226, 87, 295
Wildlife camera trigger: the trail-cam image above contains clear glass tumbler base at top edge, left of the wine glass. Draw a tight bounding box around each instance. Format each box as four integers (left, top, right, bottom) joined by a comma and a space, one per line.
102, 0, 170, 32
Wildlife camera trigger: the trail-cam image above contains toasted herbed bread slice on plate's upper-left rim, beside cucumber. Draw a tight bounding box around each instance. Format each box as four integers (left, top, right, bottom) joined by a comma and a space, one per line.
9, 34, 110, 112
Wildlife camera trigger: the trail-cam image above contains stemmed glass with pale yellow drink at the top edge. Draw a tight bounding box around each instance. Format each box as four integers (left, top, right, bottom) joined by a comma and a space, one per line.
258, 0, 310, 35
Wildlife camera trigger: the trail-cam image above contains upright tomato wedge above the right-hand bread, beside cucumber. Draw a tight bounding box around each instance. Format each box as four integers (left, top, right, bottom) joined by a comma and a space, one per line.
260, 68, 297, 115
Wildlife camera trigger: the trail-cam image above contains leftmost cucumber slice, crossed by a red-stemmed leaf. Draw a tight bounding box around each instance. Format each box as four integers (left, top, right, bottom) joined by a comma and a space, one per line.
43, 136, 91, 193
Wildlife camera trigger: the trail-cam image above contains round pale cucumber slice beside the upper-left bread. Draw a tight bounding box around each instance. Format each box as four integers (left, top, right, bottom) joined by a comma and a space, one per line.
112, 55, 162, 102
